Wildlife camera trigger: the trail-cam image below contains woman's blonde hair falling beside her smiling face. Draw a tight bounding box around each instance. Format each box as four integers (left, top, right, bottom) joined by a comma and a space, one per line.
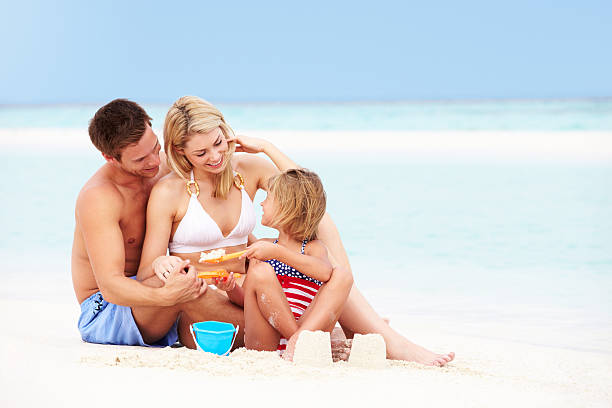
164, 96, 236, 198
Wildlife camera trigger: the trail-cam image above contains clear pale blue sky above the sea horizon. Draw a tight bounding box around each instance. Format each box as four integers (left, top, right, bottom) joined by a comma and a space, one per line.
0, 0, 612, 104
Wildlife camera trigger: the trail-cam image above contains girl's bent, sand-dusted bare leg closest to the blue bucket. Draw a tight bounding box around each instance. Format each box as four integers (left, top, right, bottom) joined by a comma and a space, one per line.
244, 262, 298, 351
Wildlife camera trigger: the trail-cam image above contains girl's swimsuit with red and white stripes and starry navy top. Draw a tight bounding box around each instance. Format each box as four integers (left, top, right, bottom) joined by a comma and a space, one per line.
266, 239, 323, 354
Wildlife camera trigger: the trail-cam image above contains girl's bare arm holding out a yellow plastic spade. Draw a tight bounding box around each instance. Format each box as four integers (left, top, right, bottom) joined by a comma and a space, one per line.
242, 240, 332, 282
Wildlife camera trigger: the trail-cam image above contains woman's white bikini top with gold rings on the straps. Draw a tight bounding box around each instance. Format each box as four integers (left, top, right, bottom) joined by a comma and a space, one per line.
168, 171, 255, 254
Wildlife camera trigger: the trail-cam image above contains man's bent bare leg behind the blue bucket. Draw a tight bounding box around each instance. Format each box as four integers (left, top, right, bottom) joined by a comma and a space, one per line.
132, 276, 244, 348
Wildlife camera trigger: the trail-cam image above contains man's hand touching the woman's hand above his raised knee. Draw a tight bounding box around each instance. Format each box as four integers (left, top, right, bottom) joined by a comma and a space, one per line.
161, 261, 208, 306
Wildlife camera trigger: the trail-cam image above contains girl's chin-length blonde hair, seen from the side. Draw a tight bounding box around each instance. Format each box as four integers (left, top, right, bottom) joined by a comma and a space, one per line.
268, 169, 326, 241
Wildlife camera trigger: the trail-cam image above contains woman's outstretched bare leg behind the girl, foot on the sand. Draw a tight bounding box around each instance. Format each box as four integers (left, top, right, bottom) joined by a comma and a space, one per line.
319, 214, 455, 366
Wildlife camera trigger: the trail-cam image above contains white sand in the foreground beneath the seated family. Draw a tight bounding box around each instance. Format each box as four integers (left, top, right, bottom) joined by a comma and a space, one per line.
0, 290, 612, 407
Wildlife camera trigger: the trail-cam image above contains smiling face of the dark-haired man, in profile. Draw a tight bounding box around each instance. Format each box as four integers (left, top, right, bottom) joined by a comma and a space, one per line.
119, 124, 161, 177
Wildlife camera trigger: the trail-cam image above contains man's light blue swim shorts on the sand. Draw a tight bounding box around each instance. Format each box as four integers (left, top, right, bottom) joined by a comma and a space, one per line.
79, 292, 178, 347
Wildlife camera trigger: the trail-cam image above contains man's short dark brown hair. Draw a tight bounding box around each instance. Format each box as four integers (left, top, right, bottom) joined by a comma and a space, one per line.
89, 99, 151, 160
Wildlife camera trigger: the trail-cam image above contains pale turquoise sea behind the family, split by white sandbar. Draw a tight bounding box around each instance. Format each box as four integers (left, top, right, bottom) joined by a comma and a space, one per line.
0, 99, 612, 352
